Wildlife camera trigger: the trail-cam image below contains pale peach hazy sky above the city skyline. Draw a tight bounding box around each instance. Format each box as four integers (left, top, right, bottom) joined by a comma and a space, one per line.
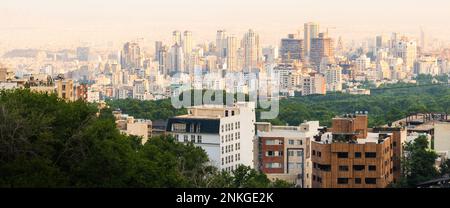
0, 0, 450, 47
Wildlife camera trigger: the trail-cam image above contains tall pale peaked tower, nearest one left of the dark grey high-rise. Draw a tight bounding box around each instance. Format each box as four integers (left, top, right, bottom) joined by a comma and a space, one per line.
242, 29, 262, 70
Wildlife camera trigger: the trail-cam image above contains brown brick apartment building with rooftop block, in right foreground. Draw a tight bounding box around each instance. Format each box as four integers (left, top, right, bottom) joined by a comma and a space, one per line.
311, 114, 406, 188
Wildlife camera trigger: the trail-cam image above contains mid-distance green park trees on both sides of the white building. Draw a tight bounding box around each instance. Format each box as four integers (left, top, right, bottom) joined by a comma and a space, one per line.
108, 84, 450, 127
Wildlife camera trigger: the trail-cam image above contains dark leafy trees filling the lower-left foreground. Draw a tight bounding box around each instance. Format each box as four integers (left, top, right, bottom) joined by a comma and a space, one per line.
0, 90, 292, 187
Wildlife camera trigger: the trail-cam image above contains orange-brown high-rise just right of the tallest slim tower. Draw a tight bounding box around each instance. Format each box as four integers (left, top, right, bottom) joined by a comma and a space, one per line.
309, 33, 334, 67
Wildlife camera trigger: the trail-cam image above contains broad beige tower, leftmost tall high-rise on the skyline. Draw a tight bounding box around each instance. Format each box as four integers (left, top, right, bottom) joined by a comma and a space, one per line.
121, 42, 142, 69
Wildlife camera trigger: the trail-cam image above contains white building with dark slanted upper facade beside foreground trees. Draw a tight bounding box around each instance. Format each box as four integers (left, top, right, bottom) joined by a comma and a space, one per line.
167, 103, 256, 171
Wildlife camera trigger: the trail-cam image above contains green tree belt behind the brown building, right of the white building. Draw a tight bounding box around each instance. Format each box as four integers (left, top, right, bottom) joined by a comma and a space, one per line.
270, 85, 450, 126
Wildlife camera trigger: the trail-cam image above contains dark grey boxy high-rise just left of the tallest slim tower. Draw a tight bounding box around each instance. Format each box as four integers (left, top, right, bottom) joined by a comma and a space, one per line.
280, 34, 303, 62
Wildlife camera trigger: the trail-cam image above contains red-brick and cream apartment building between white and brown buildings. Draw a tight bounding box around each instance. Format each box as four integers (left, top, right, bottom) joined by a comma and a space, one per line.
255, 121, 320, 188
